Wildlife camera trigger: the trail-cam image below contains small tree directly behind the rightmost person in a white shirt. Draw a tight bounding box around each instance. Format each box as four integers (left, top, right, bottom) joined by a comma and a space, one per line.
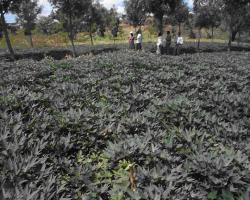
174, 2, 189, 32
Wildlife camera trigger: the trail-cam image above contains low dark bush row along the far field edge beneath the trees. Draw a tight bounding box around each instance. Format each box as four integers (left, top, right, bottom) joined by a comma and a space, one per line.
0, 42, 250, 61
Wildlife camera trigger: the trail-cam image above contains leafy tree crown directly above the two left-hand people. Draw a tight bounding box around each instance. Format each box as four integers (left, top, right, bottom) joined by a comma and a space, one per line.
124, 0, 146, 29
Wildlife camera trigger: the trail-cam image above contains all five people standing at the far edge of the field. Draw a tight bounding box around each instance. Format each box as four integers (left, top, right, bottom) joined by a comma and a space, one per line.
128, 30, 184, 55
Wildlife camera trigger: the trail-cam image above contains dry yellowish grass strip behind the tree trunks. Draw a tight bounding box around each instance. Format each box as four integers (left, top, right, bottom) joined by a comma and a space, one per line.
0, 25, 248, 48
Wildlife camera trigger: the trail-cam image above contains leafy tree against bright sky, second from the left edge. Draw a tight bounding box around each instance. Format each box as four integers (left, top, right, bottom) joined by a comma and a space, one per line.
16, 0, 42, 47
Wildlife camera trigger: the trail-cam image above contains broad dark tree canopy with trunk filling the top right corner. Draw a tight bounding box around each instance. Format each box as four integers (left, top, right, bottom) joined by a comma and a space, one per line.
194, 0, 250, 50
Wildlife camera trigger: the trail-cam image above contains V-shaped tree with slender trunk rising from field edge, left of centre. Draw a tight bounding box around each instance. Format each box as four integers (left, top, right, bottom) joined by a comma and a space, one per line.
50, 0, 92, 56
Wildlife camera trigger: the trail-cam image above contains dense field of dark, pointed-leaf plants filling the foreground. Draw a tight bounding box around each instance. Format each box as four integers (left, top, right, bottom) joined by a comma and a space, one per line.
0, 47, 250, 200
